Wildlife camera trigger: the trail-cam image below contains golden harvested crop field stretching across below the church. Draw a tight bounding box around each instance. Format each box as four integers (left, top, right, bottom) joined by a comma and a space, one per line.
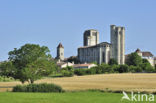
0, 73, 156, 92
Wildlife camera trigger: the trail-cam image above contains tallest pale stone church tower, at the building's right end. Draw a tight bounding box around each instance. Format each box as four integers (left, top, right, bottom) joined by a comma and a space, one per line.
110, 25, 125, 64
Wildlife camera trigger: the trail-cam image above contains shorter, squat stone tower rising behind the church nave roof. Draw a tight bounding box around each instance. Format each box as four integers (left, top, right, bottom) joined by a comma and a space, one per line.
83, 29, 99, 46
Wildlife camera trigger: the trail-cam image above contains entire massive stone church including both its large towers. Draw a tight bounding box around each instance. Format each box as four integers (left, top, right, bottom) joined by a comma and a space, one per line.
78, 25, 125, 64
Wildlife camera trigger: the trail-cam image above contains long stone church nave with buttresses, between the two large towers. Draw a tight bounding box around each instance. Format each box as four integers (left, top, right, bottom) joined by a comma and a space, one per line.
78, 42, 111, 64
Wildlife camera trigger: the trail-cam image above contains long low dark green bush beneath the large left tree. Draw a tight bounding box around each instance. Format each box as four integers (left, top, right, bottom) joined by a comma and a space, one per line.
12, 83, 64, 92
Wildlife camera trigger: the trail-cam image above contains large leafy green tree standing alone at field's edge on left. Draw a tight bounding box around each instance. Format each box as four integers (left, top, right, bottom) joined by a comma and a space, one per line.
9, 44, 54, 83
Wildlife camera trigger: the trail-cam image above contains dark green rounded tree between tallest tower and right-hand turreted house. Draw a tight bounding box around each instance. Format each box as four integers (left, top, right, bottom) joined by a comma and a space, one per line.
126, 52, 142, 66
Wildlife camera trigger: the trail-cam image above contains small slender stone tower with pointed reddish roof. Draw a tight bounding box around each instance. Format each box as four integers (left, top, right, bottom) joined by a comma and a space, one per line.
56, 43, 64, 60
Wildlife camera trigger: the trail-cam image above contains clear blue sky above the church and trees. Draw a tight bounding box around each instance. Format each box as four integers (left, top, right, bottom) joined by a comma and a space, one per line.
0, 0, 156, 61
